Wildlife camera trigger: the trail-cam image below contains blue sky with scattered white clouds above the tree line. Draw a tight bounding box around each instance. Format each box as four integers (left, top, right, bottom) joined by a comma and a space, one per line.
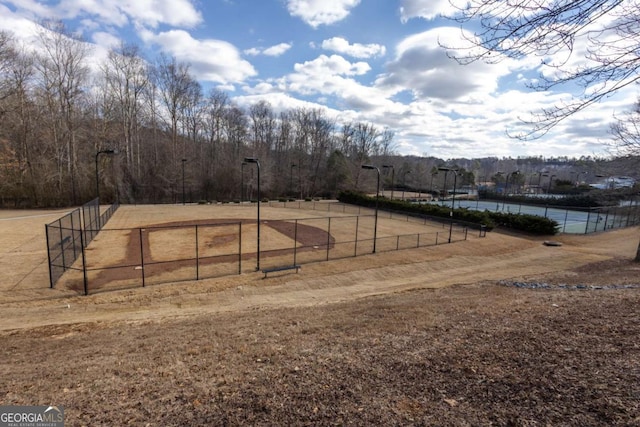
0, 0, 638, 159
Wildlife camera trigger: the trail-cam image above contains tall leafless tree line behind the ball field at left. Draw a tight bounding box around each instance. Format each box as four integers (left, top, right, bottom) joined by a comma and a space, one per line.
0, 22, 394, 206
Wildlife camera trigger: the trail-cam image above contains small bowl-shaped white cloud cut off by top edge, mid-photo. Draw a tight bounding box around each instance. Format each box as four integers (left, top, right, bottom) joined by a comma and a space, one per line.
287, 0, 360, 28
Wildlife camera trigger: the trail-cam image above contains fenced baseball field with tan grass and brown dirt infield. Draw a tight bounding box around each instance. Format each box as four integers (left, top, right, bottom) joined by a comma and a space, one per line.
56, 202, 467, 294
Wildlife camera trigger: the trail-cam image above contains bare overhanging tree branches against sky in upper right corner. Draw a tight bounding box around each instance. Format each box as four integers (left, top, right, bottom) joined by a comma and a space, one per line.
445, 0, 640, 139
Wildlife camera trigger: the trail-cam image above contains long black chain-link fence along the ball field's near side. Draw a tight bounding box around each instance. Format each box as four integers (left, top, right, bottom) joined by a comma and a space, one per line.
48, 205, 467, 295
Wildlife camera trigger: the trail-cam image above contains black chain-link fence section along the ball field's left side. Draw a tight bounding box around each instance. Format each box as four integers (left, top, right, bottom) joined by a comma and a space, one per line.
45, 198, 118, 288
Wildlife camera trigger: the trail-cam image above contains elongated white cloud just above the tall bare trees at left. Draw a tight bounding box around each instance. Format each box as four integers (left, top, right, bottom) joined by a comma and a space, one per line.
140, 30, 257, 84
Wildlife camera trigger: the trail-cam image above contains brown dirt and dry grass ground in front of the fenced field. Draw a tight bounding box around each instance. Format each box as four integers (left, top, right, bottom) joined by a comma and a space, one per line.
0, 206, 640, 426
